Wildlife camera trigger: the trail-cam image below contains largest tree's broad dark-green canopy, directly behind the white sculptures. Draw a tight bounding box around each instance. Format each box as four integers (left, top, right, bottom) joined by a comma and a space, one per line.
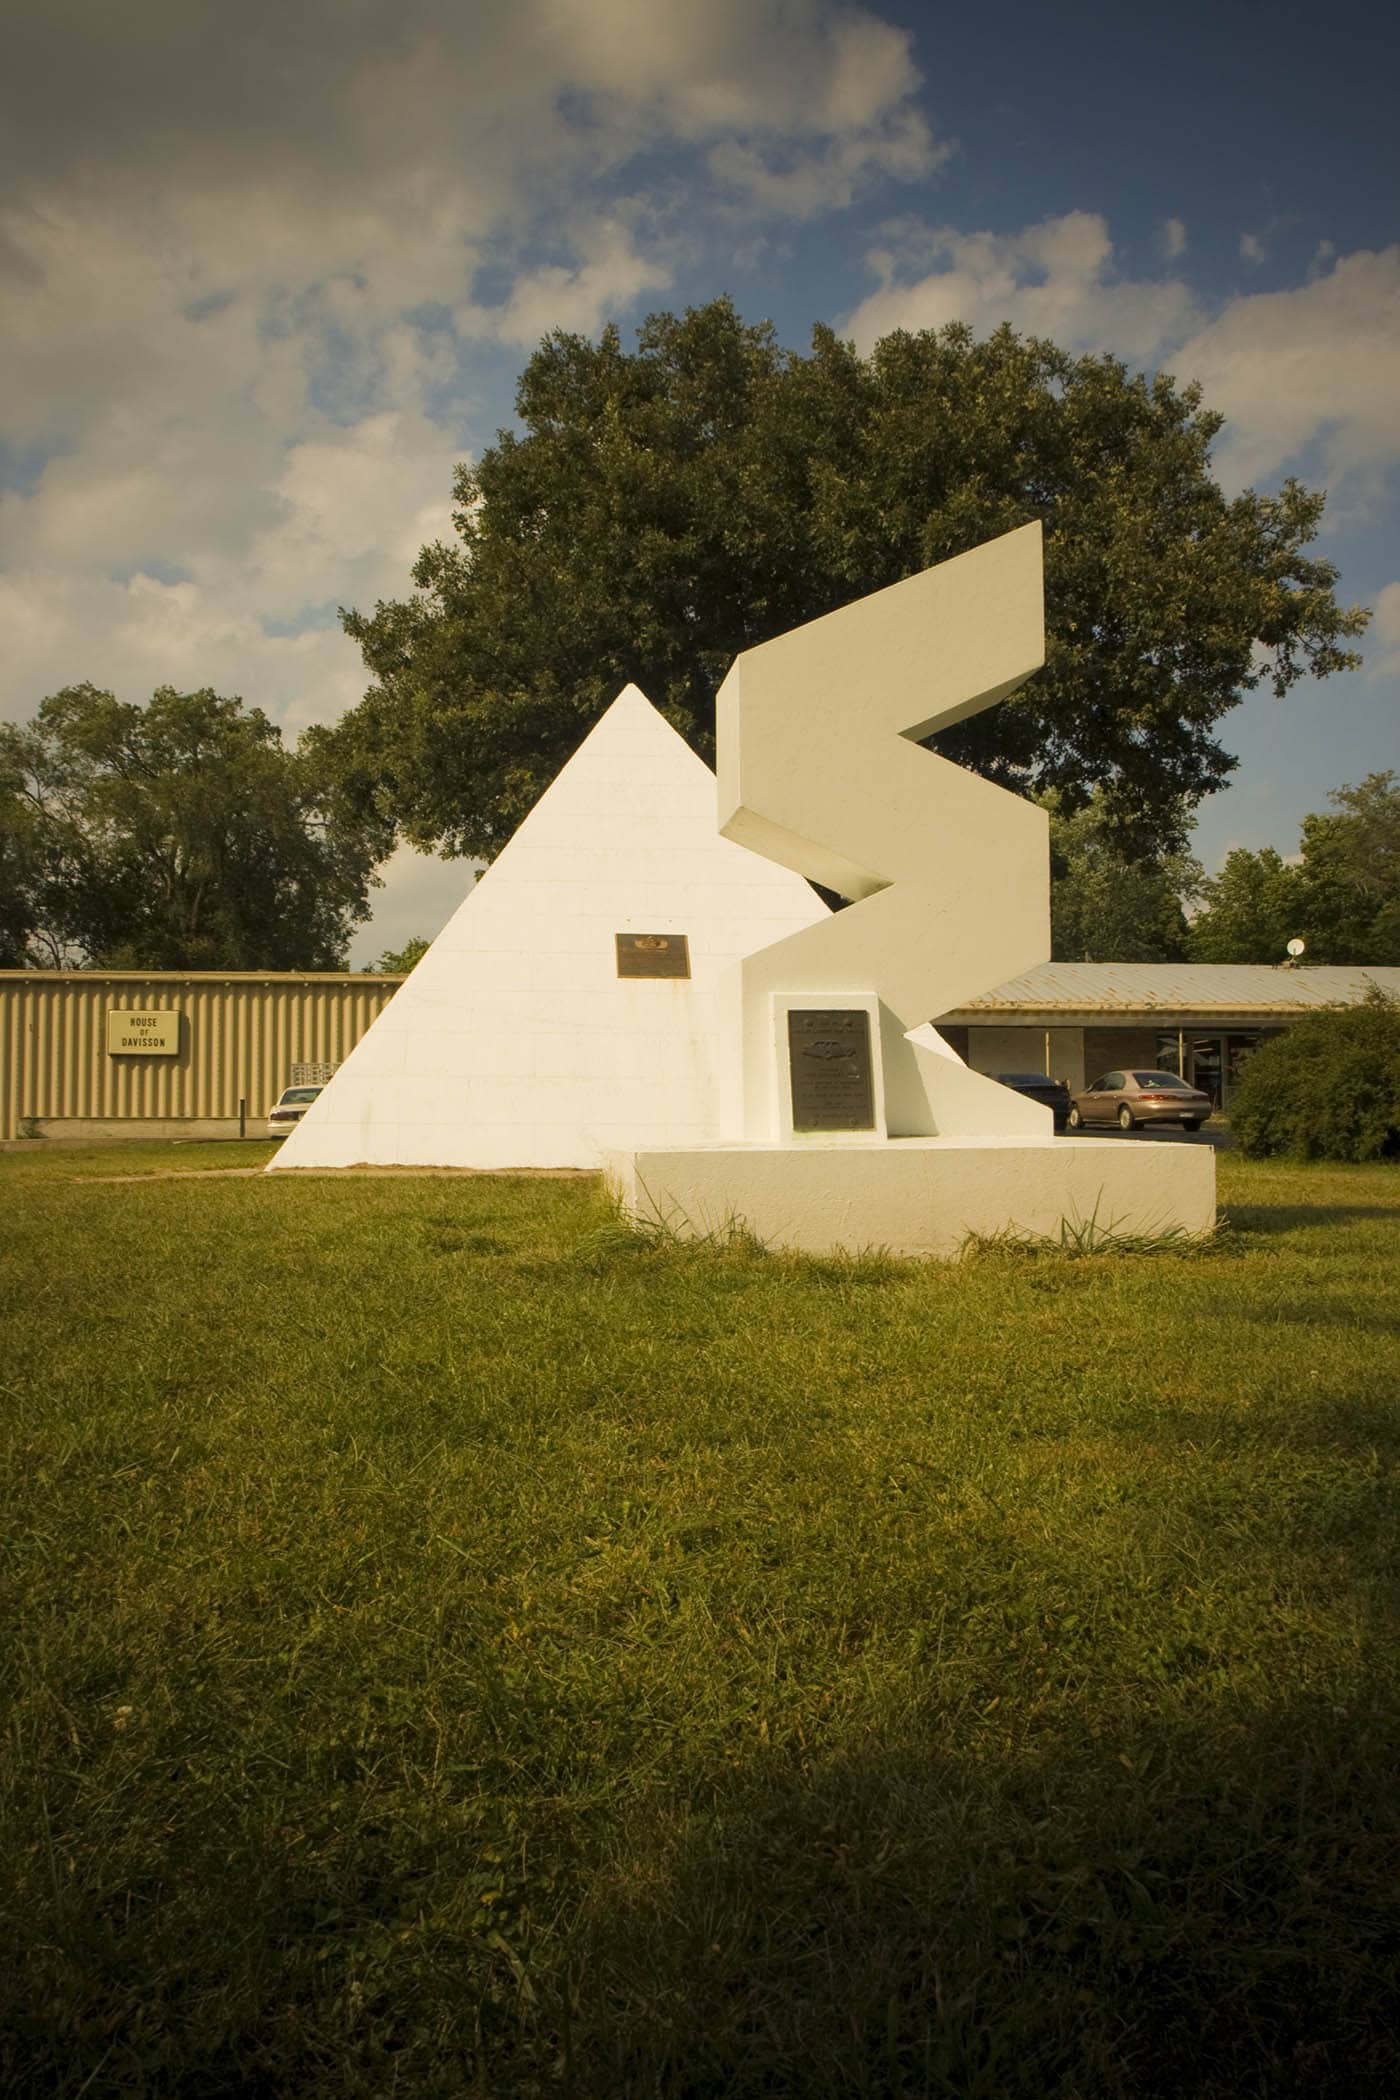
321, 300, 1366, 859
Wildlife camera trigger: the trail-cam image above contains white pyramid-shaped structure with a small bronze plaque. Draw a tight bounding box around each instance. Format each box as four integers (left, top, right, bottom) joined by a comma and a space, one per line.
273, 685, 827, 1172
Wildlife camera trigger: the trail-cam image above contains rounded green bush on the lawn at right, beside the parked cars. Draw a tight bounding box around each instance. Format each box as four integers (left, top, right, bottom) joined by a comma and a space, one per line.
1230, 985, 1400, 1159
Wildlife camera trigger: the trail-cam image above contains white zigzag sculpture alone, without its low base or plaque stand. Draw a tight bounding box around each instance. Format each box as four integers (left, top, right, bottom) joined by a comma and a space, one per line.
718, 525, 1052, 1142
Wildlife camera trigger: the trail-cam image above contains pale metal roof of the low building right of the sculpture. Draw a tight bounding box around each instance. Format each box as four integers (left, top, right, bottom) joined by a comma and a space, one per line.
940, 962, 1400, 1021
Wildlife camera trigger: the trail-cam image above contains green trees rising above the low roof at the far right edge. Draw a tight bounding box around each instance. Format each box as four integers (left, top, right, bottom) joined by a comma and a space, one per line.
1188, 773, 1400, 964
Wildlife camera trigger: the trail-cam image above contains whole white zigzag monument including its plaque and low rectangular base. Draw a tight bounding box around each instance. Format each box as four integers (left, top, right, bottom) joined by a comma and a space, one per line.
607, 525, 1215, 1254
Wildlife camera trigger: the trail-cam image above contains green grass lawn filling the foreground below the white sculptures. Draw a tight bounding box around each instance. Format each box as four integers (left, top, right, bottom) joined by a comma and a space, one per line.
0, 1147, 1400, 2100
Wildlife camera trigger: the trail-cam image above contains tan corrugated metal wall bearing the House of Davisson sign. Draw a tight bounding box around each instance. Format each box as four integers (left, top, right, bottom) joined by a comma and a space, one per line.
0, 970, 401, 1138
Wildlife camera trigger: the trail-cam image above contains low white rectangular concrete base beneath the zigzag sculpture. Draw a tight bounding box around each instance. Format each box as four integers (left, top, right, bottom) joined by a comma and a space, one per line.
602, 1138, 1215, 1258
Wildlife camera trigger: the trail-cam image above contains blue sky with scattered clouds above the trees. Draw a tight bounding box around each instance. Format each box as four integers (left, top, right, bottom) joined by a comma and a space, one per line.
0, 0, 1400, 960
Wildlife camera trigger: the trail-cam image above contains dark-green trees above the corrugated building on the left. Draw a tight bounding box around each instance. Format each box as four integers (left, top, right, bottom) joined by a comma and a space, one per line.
0, 685, 384, 970
